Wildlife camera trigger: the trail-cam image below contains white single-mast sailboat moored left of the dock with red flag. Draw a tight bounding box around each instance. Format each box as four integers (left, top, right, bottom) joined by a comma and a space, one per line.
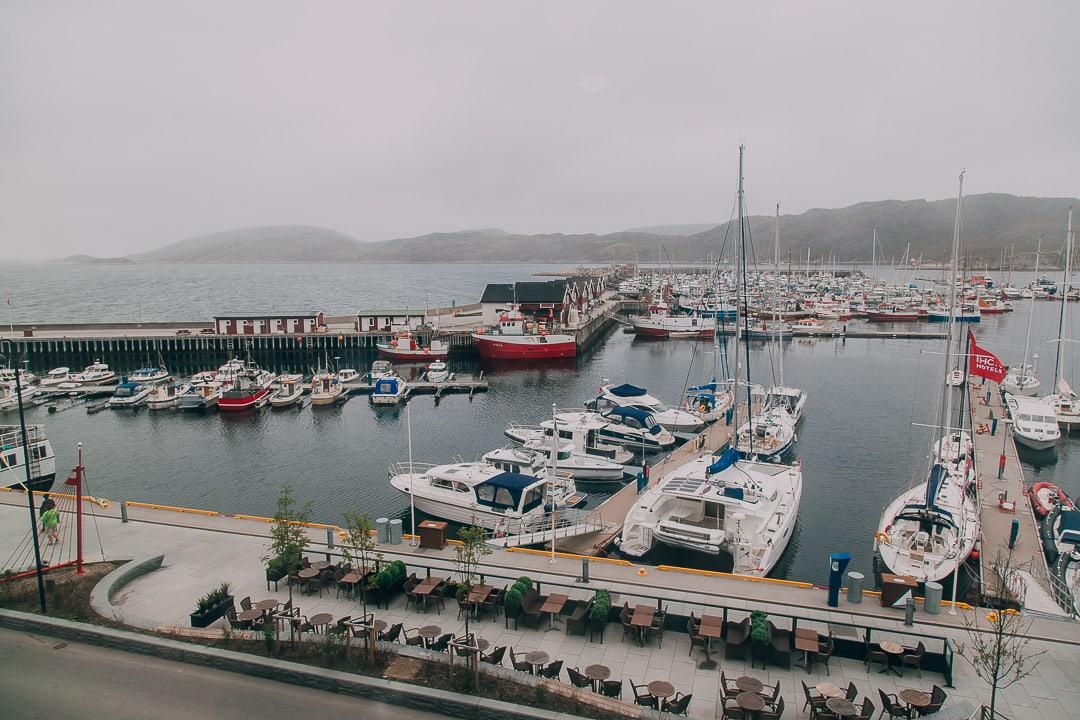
875, 173, 978, 587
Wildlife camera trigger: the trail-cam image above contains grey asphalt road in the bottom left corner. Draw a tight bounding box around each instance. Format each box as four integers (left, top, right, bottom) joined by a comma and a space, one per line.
0, 629, 443, 720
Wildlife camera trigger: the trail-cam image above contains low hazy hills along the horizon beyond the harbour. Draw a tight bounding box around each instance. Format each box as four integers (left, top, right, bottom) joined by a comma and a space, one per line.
67, 193, 1080, 266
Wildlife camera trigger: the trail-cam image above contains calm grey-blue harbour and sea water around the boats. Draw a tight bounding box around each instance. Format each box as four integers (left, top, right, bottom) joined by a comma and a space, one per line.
4, 266, 1080, 582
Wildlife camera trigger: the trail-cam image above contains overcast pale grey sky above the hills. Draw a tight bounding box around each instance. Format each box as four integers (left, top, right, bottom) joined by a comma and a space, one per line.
0, 0, 1080, 259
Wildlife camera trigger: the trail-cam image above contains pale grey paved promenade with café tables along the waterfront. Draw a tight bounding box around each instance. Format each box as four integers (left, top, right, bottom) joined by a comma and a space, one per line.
0, 493, 1080, 720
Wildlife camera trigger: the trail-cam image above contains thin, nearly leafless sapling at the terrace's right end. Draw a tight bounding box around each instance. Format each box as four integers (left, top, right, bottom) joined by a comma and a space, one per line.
957, 547, 1042, 720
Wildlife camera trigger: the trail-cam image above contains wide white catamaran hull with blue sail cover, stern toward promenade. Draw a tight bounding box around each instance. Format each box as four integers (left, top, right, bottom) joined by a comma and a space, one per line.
619, 448, 802, 578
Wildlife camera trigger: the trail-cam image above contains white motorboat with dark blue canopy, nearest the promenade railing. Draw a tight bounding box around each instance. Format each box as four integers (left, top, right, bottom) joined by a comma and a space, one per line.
388, 462, 577, 534
